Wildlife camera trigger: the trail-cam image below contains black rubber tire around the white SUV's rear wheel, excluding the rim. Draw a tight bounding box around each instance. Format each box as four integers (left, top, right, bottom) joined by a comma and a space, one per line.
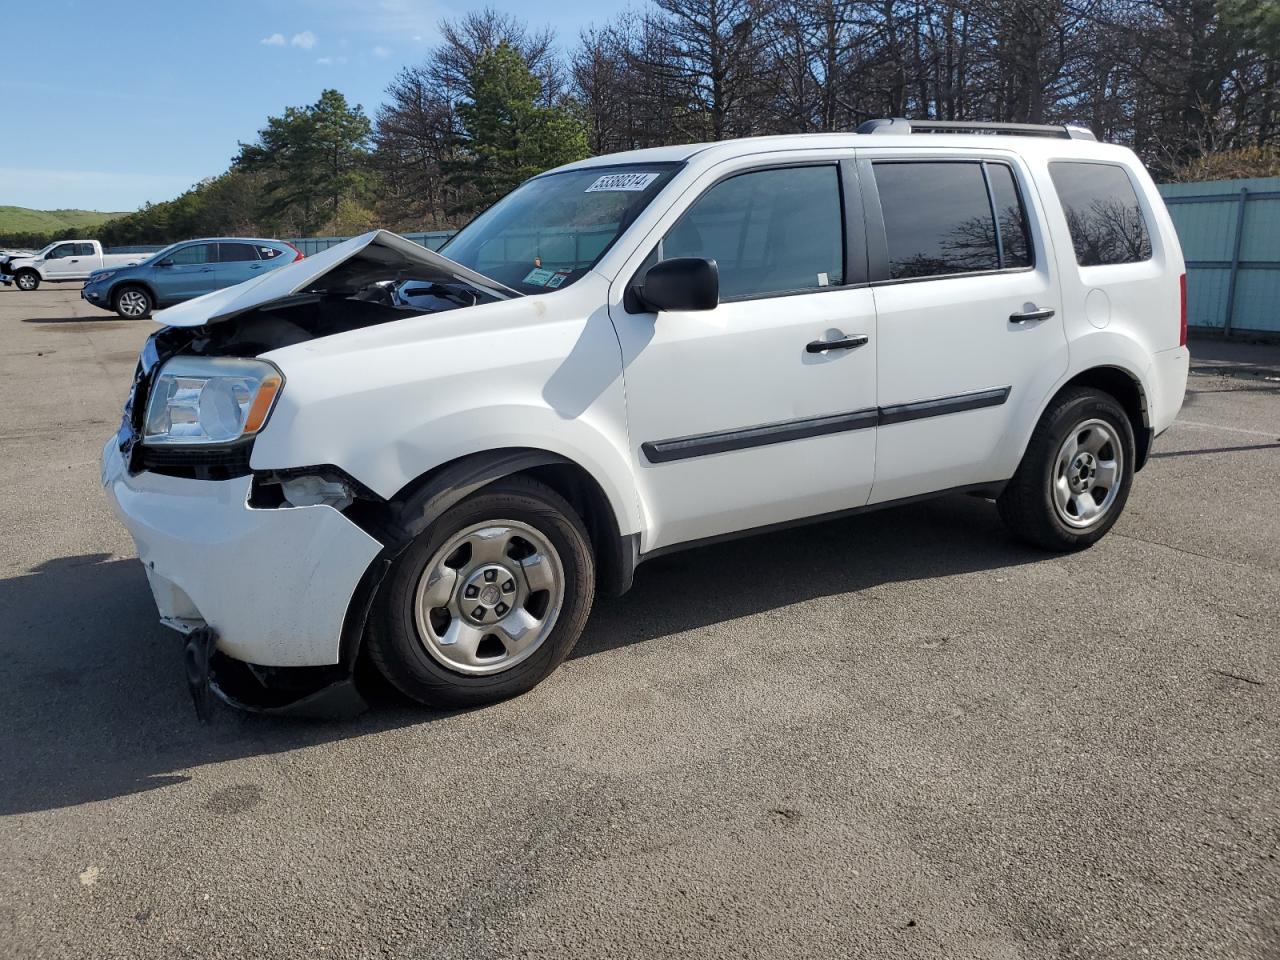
996, 387, 1137, 552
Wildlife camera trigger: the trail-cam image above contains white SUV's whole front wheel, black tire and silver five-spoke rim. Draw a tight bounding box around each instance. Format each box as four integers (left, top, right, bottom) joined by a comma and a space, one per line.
369, 477, 595, 707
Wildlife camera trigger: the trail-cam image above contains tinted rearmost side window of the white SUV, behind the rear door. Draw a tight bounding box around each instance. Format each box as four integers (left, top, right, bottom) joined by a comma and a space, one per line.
1048, 160, 1151, 266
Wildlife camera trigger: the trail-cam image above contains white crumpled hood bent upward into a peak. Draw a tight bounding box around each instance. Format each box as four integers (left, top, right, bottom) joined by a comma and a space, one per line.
154, 230, 509, 326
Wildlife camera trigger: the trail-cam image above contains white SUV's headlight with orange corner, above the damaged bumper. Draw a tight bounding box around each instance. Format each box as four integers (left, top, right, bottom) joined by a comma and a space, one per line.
142, 357, 284, 445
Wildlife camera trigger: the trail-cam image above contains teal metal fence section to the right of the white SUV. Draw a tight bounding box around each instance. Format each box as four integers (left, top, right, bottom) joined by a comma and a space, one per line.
1160, 177, 1280, 337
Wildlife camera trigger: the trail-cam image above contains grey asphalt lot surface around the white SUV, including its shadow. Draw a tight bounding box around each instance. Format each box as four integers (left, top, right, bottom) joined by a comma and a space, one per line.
0, 287, 1280, 960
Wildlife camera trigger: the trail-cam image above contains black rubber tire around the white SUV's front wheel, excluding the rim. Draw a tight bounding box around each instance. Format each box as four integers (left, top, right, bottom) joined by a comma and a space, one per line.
367, 477, 595, 707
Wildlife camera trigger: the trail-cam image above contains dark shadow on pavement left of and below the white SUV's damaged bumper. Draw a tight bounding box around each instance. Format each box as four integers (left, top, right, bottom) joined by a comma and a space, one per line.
0, 554, 432, 815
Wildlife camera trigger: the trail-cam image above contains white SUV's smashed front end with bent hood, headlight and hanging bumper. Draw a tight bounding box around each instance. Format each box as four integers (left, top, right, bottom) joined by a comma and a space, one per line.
111, 230, 521, 719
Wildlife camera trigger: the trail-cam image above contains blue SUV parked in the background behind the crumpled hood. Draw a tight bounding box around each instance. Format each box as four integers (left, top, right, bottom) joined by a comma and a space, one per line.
81, 237, 302, 320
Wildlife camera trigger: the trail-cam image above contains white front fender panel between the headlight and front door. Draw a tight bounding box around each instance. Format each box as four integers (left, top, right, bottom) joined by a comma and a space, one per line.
252, 289, 640, 534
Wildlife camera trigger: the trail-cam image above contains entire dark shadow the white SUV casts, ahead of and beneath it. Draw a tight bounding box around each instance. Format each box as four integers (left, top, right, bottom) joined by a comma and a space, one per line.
0, 497, 1046, 815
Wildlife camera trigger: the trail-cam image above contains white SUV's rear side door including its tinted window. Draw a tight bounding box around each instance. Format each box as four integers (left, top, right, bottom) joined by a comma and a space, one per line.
858, 148, 1068, 503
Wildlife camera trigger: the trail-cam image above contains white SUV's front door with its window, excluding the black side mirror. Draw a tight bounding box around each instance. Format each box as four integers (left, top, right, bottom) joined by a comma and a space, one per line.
611, 160, 876, 552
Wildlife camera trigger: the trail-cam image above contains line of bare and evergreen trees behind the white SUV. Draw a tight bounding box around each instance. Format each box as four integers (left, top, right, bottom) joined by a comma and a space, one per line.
5, 0, 1280, 244
